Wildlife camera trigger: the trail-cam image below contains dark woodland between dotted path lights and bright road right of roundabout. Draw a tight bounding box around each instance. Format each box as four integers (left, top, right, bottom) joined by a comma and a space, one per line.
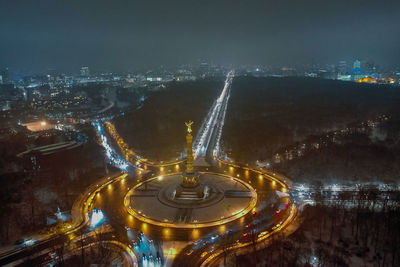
274, 120, 400, 183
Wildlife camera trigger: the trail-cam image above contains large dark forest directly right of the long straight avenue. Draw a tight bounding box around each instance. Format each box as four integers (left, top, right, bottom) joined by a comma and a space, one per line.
223, 77, 400, 162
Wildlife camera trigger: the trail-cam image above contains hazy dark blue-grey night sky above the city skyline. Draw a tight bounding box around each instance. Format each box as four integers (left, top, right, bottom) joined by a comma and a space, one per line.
0, 0, 400, 71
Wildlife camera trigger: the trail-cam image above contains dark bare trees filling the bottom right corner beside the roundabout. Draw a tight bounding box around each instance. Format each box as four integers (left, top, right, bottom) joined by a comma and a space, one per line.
232, 188, 400, 267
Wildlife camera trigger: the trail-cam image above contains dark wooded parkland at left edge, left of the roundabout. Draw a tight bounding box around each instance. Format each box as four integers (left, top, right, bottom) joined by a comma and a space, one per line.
0, 125, 109, 244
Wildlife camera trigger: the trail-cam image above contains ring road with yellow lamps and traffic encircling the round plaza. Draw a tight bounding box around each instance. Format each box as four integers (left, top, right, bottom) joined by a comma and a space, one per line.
86, 162, 296, 266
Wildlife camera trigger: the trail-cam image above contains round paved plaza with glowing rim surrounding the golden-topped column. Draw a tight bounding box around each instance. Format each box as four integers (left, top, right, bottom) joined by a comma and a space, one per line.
125, 173, 257, 228
